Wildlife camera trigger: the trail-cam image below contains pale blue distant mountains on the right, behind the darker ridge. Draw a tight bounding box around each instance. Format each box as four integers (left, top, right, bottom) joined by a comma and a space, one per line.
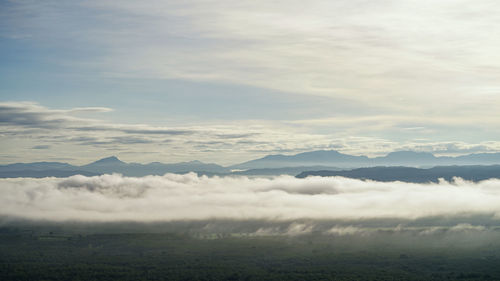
230, 150, 500, 169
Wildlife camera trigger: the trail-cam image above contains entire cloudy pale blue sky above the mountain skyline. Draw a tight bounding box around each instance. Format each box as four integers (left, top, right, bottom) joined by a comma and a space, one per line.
0, 0, 500, 165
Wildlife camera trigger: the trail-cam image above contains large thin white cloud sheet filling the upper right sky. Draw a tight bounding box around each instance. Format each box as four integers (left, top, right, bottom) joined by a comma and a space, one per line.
76, 0, 500, 118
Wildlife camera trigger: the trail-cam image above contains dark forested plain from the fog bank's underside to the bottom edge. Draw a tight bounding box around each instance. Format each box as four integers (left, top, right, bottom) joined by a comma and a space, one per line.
0, 218, 500, 280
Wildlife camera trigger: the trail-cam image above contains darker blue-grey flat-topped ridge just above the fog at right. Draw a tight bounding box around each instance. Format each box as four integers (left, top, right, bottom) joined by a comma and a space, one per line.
297, 165, 500, 183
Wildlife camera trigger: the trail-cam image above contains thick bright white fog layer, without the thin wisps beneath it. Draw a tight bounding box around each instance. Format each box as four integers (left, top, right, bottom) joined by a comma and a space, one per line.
0, 173, 500, 223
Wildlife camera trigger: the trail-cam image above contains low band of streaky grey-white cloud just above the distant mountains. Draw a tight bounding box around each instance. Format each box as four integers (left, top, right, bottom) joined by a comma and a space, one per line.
0, 102, 500, 165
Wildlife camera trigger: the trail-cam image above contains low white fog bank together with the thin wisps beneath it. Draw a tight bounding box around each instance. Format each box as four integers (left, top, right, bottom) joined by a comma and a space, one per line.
0, 171, 500, 249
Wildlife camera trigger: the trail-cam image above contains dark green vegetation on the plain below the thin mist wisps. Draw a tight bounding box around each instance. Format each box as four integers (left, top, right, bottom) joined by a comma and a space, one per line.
0, 228, 500, 280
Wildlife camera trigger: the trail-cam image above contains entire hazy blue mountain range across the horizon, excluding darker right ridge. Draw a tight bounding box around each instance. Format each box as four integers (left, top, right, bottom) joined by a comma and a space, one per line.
0, 150, 500, 178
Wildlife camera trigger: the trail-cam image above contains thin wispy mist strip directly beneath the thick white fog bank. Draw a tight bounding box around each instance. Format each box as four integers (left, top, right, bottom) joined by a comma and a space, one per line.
0, 217, 500, 250
